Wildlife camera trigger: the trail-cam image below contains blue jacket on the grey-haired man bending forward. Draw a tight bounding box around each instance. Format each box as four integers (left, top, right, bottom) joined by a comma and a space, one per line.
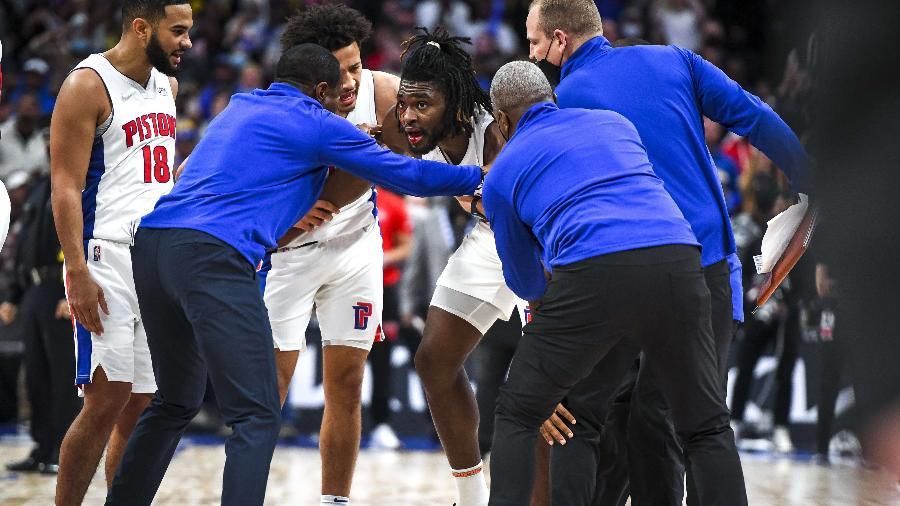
483, 102, 699, 300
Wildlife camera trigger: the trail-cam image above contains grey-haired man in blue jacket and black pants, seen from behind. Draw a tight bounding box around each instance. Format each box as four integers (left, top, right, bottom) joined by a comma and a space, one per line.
483, 62, 747, 506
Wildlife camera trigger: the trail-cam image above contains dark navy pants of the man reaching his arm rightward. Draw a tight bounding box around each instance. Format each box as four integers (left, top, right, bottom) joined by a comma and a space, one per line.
106, 228, 281, 505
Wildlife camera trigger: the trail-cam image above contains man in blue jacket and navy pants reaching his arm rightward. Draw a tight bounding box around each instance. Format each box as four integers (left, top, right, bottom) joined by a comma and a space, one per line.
106, 44, 482, 506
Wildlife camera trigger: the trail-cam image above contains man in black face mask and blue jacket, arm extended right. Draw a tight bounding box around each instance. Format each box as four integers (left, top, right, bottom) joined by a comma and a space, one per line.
526, 0, 807, 505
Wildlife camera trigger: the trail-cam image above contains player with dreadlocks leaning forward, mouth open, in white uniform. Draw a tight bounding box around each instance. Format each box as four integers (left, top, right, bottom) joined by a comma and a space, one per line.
384, 28, 521, 506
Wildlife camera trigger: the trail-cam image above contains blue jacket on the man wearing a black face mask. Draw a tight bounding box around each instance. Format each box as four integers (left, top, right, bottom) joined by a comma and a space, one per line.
551, 36, 808, 320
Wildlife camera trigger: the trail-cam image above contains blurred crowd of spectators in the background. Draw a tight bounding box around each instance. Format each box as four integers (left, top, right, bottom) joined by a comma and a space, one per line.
0, 0, 854, 466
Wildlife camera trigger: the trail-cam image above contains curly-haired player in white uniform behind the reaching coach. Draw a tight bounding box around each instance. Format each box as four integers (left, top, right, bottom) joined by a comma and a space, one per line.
261, 4, 399, 504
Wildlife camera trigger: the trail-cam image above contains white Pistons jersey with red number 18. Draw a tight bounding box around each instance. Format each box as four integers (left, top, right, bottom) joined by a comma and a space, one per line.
75, 54, 175, 243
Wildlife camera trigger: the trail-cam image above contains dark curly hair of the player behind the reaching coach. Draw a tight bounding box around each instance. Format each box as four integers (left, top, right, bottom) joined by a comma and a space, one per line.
281, 2, 372, 51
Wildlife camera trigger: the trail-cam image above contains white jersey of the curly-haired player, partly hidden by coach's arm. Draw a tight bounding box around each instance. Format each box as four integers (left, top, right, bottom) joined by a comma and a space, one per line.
291, 69, 378, 245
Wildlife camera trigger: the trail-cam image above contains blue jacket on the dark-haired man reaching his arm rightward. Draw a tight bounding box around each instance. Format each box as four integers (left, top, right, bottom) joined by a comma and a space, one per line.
140, 83, 481, 266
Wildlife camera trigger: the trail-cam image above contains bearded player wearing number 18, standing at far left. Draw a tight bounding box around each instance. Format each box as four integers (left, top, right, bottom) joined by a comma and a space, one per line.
50, 0, 193, 505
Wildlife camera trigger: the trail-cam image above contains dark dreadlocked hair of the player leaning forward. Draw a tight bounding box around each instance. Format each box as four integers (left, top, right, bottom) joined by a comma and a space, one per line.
400, 26, 493, 135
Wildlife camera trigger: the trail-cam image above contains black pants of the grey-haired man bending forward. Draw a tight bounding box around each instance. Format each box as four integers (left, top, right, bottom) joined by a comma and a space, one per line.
490, 246, 747, 505
